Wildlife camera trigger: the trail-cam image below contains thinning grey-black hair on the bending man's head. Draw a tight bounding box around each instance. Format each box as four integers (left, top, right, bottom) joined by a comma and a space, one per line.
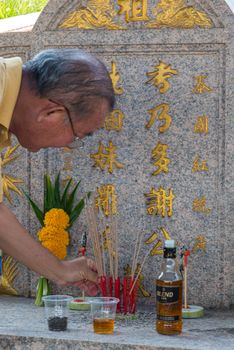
23, 49, 115, 117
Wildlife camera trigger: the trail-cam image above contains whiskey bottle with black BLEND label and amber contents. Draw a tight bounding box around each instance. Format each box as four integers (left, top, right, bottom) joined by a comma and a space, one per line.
156, 240, 182, 335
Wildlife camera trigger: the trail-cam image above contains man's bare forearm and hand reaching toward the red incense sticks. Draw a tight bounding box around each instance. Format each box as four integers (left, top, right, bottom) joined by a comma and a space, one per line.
0, 203, 98, 295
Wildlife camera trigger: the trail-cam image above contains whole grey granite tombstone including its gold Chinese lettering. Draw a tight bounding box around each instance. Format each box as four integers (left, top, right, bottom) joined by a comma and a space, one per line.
0, 0, 234, 307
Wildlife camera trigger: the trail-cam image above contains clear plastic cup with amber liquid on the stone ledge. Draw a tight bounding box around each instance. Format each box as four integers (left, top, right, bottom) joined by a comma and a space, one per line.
89, 297, 119, 334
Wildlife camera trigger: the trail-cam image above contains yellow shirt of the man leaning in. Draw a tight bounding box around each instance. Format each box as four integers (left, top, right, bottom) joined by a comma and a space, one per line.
0, 57, 22, 203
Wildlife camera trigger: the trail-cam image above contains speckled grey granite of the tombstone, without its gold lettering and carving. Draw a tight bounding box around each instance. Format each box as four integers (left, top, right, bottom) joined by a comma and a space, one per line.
0, 0, 234, 307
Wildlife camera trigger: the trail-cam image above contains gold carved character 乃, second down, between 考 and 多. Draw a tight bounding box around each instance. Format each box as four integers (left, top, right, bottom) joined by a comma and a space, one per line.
146, 103, 171, 133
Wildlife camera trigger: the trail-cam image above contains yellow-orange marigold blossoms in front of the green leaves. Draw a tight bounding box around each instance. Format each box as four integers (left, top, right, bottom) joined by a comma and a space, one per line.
37, 208, 69, 260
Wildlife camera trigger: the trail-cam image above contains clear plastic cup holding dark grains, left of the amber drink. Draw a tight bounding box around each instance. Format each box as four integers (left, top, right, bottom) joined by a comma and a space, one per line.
42, 295, 73, 331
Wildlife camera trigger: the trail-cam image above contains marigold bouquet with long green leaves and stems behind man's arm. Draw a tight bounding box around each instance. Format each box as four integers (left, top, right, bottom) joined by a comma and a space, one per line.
25, 173, 85, 306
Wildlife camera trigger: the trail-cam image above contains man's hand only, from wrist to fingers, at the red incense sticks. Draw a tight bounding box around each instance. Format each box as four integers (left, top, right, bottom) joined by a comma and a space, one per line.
59, 256, 98, 296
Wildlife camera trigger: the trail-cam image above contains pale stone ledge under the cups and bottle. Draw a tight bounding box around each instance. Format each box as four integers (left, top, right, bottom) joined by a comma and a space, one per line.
0, 296, 234, 350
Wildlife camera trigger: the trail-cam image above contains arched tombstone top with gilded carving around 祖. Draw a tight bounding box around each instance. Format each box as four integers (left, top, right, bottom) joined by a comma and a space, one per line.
34, 0, 232, 32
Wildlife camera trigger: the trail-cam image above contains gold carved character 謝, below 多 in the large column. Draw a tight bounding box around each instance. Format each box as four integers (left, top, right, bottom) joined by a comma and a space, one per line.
145, 187, 175, 218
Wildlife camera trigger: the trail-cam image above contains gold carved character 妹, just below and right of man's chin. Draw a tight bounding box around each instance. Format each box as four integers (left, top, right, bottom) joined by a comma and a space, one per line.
90, 141, 124, 174
